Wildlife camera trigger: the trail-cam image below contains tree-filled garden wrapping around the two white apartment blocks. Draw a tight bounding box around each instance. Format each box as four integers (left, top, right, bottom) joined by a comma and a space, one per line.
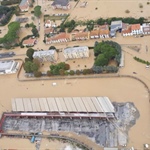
23, 41, 121, 77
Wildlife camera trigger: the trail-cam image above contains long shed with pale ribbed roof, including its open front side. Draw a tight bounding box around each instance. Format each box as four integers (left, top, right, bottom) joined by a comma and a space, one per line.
12, 97, 115, 117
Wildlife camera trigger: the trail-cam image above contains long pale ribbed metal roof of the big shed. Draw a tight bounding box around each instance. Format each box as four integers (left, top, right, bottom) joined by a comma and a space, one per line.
12, 97, 115, 113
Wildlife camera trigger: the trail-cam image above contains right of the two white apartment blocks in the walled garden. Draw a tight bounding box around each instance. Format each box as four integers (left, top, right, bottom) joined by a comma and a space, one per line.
64, 46, 89, 60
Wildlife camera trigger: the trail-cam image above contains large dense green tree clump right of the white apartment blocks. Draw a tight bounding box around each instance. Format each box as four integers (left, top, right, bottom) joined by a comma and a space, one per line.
94, 41, 121, 66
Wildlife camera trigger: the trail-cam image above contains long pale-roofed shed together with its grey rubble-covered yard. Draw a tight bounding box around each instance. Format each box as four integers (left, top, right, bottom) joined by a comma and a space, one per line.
0, 97, 140, 147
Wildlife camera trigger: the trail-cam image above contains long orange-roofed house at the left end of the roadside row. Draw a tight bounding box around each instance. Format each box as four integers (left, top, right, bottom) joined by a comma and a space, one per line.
46, 32, 70, 44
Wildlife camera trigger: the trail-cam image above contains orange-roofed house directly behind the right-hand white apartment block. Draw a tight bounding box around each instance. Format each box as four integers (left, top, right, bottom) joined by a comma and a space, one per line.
72, 32, 89, 40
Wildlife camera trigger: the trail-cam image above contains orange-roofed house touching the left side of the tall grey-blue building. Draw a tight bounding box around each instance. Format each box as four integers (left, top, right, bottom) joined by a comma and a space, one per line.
99, 24, 110, 38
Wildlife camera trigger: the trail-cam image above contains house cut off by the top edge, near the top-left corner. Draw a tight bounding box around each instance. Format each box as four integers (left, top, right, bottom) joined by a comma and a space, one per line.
19, 0, 32, 12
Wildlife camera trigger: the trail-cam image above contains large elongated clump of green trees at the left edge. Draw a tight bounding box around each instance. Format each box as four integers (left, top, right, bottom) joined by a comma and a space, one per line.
0, 22, 20, 48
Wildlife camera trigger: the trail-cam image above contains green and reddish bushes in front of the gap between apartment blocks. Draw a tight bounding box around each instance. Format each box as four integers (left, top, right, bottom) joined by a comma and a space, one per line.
50, 62, 70, 75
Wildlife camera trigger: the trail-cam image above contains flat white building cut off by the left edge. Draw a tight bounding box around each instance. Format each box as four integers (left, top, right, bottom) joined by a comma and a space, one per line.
0, 60, 19, 74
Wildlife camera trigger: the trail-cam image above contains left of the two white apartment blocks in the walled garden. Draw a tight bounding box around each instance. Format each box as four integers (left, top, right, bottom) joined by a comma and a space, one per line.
33, 50, 58, 62
